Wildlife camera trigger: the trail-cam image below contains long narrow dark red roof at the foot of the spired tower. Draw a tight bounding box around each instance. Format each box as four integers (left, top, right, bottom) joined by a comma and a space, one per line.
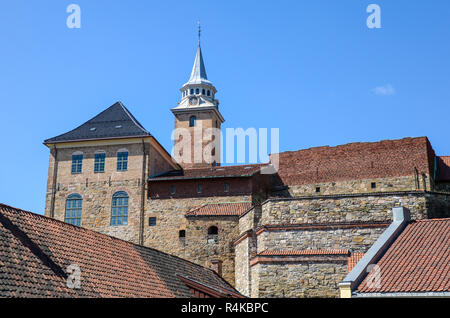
149, 164, 265, 181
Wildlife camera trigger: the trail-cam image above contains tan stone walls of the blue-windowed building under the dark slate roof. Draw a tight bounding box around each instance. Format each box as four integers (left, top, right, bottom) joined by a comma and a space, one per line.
45, 139, 174, 243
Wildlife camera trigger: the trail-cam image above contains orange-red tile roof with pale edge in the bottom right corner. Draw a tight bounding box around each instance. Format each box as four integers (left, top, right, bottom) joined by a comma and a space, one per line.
357, 218, 450, 293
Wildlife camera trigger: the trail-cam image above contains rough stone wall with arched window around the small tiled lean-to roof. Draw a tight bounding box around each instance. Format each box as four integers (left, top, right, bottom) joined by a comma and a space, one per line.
144, 195, 251, 283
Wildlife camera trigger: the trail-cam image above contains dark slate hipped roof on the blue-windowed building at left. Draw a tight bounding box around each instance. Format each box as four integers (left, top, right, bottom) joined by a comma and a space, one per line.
44, 102, 151, 144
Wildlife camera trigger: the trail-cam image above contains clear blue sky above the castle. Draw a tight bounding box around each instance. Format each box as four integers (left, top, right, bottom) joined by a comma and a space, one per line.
0, 0, 450, 213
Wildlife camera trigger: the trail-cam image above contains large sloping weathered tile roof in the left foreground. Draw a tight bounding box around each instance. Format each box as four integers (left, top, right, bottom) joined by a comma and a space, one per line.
0, 204, 243, 297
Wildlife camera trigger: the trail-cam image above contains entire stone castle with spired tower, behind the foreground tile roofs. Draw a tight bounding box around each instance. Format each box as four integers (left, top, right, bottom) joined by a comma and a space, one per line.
44, 44, 450, 297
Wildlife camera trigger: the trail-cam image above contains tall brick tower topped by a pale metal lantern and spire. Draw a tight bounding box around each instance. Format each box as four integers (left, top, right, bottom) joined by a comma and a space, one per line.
171, 29, 225, 168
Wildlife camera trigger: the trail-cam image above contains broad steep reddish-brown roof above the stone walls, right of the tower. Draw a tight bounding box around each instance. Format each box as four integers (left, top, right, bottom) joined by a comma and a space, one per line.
274, 137, 434, 185
